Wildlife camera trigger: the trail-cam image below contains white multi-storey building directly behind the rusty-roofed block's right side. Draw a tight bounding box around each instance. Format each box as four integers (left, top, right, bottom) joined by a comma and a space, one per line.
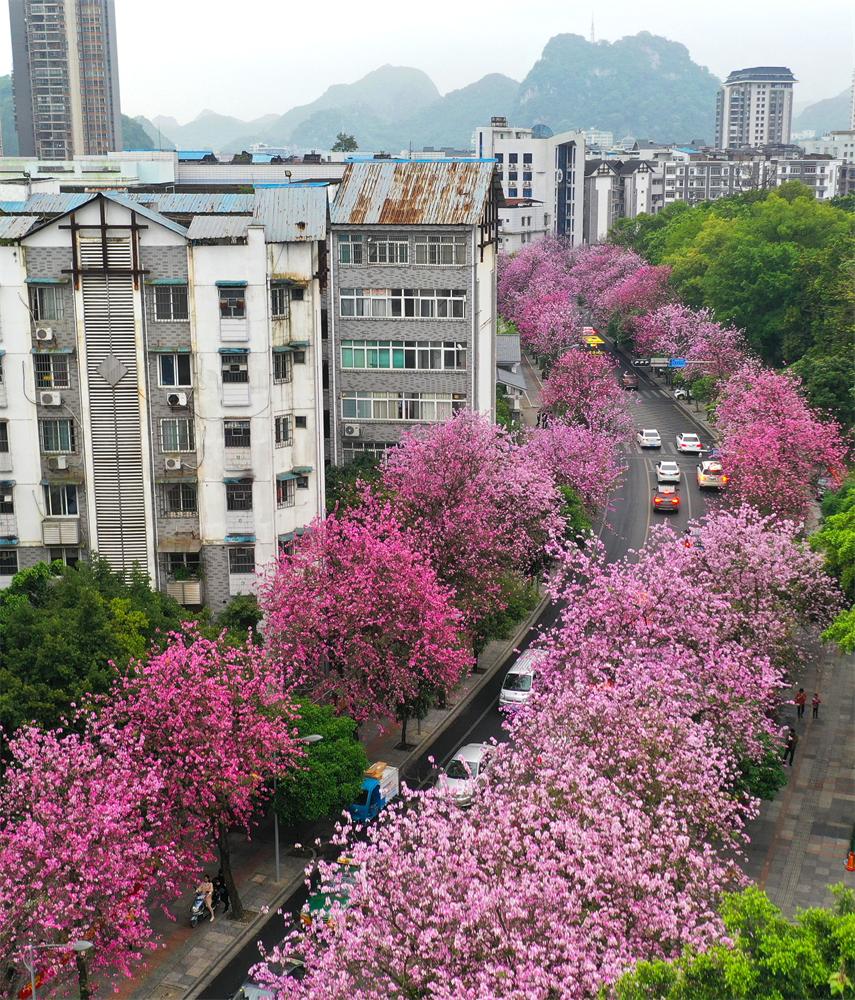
474, 118, 585, 253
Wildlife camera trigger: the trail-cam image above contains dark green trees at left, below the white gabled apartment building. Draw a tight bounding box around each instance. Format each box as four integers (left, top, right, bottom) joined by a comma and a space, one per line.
0, 558, 186, 732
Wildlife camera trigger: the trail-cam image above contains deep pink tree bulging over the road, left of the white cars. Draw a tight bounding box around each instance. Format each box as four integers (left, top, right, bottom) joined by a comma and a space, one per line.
542, 350, 634, 441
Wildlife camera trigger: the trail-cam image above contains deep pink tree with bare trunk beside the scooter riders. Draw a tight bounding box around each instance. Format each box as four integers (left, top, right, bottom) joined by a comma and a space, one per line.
91, 624, 303, 919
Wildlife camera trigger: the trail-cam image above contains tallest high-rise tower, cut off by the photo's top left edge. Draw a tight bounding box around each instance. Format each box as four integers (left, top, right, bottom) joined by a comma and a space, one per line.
9, 0, 122, 160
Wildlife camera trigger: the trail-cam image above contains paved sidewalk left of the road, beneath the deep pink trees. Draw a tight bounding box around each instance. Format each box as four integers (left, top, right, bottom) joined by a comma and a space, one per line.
114, 598, 546, 1000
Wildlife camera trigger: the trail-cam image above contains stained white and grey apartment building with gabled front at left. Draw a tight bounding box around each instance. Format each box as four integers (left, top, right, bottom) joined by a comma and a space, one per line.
0, 185, 328, 610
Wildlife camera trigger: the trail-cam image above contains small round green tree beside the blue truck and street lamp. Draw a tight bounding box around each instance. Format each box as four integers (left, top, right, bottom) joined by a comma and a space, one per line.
273, 701, 368, 826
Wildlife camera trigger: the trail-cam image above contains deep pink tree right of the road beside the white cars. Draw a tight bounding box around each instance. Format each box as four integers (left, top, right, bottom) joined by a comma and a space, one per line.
716, 364, 847, 521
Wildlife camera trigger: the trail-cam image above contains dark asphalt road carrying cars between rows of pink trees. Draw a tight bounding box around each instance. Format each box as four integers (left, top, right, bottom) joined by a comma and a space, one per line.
200, 367, 710, 1000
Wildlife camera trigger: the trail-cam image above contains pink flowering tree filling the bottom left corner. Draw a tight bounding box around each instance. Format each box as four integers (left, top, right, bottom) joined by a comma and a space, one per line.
0, 728, 189, 997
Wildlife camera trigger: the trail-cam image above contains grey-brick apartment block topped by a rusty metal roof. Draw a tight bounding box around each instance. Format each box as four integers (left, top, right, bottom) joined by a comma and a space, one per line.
327, 160, 502, 464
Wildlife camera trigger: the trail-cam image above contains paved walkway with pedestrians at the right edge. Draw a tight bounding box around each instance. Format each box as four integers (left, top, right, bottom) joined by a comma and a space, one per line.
745, 649, 855, 915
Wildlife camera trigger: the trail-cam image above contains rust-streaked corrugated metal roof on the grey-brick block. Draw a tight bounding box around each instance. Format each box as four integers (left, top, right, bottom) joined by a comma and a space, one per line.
330, 160, 494, 226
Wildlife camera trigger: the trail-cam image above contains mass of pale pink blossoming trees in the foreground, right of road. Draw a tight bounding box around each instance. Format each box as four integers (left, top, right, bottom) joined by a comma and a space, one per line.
255, 509, 835, 1000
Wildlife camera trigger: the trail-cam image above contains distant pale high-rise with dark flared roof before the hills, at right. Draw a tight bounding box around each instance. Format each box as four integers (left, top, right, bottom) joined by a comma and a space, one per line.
715, 66, 796, 149
